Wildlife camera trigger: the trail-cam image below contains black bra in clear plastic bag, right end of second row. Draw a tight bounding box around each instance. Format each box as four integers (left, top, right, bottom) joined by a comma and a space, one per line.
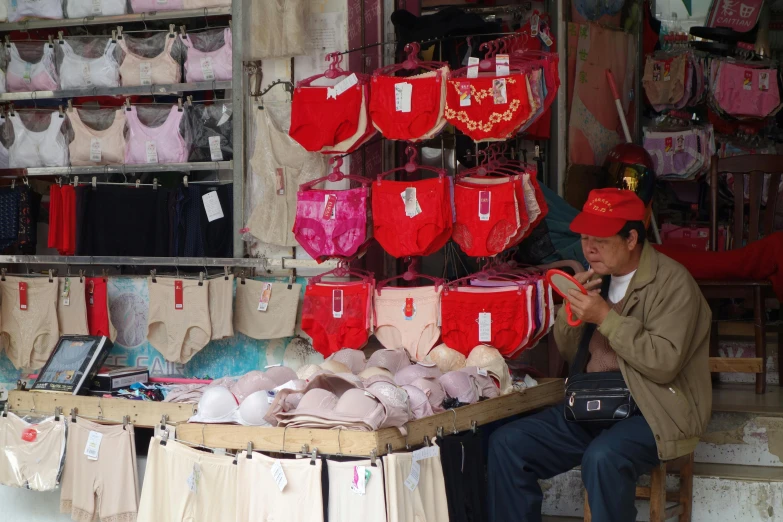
187, 102, 234, 161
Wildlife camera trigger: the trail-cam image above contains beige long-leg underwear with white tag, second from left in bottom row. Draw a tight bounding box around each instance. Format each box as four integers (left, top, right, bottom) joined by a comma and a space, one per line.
60, 417, 139, 522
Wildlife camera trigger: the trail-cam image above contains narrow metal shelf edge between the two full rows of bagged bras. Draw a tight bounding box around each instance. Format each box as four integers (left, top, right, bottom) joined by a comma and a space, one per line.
0, 81, 232, 103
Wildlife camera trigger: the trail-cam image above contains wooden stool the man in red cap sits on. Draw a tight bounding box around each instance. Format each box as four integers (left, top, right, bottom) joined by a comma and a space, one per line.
585, 453, 693, 522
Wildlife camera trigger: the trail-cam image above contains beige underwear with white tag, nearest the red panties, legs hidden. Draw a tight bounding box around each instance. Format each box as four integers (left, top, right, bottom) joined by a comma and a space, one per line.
234, 279, 302, 339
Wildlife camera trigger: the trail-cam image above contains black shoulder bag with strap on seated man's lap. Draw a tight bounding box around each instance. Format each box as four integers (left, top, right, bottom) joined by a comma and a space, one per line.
563, 277, 637, 423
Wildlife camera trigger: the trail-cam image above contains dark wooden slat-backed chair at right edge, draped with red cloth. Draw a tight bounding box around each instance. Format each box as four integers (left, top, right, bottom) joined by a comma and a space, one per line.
698, 154, 783, 394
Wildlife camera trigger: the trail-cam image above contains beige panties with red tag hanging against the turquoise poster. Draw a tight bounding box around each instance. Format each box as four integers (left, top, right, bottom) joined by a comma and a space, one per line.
147, 277, 212, 364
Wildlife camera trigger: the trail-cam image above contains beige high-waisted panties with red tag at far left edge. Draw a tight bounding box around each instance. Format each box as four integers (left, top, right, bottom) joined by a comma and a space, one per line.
0, 276, 60, 370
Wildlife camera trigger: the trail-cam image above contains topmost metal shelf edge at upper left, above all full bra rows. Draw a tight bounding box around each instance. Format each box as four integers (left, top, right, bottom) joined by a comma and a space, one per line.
0, 6, 231, 32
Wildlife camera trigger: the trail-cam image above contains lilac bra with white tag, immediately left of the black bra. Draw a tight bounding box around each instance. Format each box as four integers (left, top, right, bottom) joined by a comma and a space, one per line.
125, 105, 188, 165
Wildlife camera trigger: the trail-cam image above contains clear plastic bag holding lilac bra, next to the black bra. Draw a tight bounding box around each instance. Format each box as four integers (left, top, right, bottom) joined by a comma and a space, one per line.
123, 105, 192, 164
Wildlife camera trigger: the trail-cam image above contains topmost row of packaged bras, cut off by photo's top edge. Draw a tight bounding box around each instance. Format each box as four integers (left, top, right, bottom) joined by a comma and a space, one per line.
8, 0, 231, 22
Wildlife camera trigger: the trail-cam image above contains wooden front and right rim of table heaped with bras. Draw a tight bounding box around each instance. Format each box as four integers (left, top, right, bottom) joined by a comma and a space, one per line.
176, 379, 565, 457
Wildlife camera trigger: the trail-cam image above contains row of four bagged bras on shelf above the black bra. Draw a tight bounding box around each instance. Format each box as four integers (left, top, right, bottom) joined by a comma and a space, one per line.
0, 29, 232, 92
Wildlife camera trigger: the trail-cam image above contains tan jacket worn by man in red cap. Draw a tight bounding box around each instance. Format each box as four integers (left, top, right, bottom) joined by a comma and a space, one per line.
555, 242, 712, 460
